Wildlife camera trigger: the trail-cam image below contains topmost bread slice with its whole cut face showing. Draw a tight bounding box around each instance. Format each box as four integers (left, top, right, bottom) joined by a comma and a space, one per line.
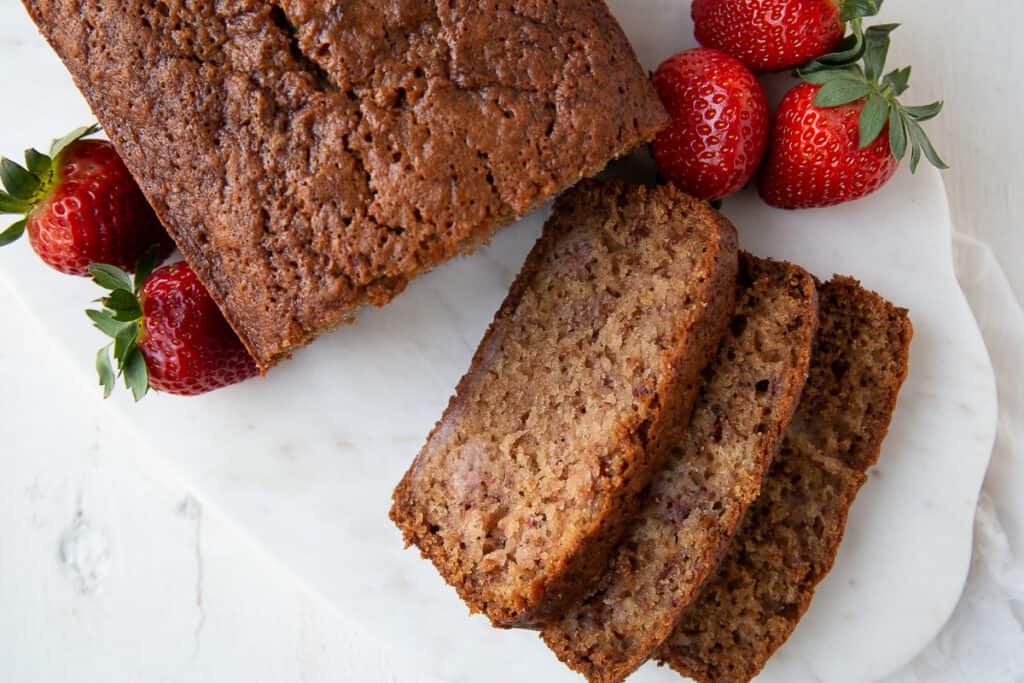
391, 182, 737, 626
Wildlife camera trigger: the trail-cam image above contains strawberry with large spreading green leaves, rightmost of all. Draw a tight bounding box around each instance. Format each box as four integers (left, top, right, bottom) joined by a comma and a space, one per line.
758, 25, 947, 209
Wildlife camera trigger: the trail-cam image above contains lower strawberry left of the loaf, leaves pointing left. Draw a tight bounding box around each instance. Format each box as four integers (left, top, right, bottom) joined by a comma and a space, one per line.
86, 251, 259, 400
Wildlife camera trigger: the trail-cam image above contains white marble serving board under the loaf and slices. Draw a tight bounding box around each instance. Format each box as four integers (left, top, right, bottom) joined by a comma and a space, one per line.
0, 0, 996, 683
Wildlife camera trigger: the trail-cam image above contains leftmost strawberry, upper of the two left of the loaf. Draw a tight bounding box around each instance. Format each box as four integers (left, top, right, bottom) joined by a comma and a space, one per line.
0, 126, 174, 275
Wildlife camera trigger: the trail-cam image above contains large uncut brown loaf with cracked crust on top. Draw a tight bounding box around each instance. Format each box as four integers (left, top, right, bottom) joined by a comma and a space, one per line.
25, 0, 668, 370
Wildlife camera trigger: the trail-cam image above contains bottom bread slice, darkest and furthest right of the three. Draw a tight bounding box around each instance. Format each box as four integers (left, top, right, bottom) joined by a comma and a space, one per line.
657, 278, 913, 683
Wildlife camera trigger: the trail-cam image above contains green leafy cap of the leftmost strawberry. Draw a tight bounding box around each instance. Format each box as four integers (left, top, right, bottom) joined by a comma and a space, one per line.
0, 124, 99, 247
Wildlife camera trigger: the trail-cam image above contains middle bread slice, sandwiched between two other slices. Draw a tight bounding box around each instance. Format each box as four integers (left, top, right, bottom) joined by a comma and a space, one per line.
543, 254, 817, 683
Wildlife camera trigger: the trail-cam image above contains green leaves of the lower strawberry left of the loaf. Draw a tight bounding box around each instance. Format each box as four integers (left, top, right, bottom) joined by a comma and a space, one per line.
85, 247, 160, 401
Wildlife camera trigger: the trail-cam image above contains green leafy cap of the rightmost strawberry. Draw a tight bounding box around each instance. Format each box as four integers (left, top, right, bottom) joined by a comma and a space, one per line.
797, 24, 949, 172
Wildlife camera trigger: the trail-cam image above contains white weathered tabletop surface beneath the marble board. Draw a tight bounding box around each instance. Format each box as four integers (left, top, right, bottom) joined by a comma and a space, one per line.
0, 0, 1024, 682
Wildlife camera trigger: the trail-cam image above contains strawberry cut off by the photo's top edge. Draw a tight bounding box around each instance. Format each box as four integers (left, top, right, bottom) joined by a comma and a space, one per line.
690, 0, 882, 73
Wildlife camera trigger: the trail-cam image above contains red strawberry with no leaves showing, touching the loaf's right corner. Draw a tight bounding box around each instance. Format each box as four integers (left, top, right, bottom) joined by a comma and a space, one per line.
653, 48, 768, 200
